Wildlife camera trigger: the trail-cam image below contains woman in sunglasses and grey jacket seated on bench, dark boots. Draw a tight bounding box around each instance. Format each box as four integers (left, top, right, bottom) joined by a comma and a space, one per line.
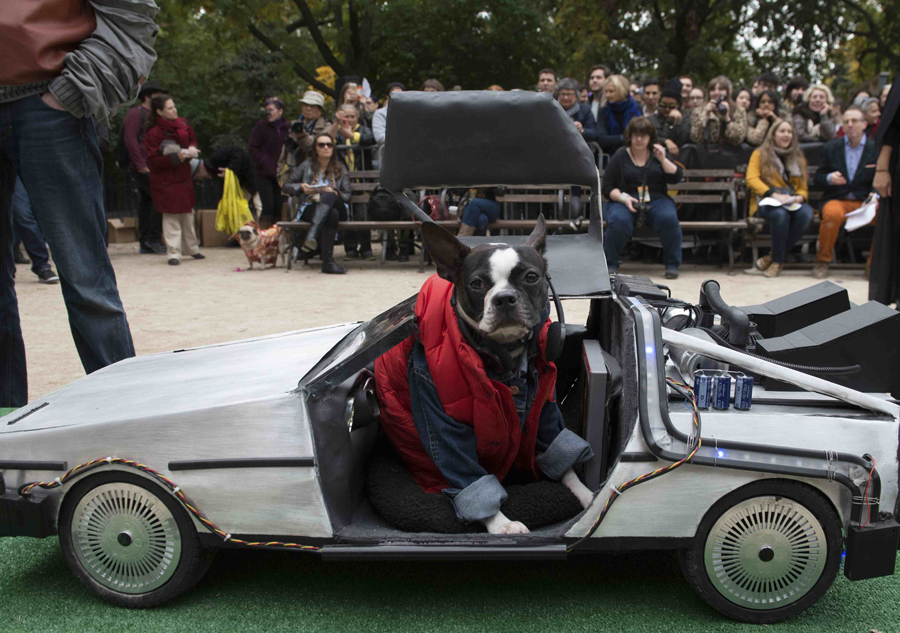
284, 134, 350, 275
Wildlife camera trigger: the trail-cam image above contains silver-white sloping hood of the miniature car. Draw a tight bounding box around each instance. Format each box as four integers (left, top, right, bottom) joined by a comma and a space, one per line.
0, 323, 358, 436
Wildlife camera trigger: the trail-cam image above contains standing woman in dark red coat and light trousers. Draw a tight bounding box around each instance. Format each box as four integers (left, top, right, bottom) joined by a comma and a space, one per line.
144, 94, 203, 266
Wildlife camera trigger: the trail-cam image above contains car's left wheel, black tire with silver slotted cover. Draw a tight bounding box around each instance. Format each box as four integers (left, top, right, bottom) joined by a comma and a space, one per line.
59, 471, 213, 608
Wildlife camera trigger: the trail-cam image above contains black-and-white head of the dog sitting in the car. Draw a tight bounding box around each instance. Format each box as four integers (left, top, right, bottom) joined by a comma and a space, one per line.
422, 215, 549, 343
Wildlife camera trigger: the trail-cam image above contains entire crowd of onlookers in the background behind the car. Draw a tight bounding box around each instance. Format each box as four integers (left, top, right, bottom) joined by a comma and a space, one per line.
114, 64, 890, 278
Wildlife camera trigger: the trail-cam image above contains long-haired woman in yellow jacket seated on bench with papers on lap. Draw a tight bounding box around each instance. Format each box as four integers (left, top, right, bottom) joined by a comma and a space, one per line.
747, 120, 813, 277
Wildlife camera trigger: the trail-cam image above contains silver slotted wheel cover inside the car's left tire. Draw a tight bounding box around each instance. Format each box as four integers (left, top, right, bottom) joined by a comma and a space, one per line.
72, 483, 181, 594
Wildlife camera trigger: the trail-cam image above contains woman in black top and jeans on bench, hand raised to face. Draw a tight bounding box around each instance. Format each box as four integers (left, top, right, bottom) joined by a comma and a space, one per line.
602, 117, 683, 279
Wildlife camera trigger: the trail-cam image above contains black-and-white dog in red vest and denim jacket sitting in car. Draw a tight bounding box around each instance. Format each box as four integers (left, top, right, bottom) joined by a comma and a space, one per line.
375, 216, 593, 534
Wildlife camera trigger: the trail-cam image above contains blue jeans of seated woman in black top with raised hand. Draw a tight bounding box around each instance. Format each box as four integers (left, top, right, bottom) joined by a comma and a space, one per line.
603, 198, 681, 268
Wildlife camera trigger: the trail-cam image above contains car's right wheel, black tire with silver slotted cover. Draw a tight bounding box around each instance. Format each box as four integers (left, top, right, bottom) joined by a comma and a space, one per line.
679, 480, 843, 624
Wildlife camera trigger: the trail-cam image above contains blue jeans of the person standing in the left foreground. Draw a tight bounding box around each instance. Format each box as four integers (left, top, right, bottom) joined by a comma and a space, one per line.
0, 95, 134, 407
